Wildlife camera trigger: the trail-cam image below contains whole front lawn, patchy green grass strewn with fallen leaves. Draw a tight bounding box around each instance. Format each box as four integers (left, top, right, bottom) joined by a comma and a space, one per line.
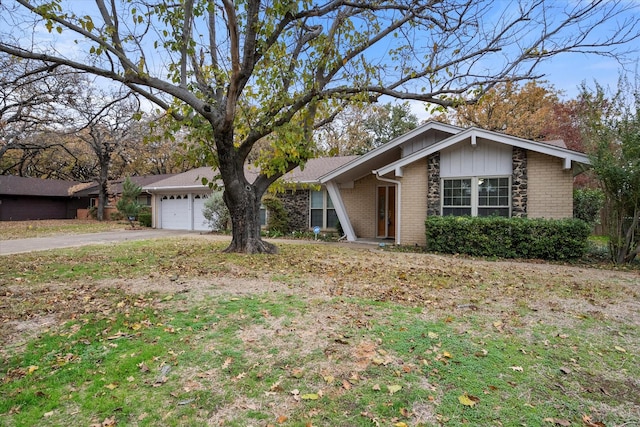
0, 229, 640, 427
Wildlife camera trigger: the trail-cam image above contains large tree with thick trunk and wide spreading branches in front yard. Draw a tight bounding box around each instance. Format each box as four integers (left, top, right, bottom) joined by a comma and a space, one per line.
0, 0, 640, 252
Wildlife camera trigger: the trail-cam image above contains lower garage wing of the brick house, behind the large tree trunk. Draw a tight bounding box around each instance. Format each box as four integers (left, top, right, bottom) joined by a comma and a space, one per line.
143, 156, 357, 231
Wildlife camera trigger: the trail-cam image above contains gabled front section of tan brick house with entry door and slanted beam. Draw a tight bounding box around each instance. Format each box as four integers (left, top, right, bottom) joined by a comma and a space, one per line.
320, 122, 589, 245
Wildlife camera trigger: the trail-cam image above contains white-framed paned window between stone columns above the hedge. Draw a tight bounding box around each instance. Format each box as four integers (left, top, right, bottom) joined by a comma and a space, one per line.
442, 177, 511, 217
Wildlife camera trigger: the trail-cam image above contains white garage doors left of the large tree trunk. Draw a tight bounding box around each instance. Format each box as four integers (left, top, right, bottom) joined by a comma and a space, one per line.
158, 193, 209, 231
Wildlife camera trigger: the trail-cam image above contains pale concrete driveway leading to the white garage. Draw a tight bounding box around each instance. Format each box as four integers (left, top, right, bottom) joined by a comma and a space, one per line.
0, 229, 220, 255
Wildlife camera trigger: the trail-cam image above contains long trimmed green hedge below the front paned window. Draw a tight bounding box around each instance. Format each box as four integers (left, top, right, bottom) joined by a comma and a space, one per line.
425, 216, 591, 260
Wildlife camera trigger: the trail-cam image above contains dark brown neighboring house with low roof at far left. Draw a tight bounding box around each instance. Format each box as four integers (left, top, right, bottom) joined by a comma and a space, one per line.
0, 175, 89, 221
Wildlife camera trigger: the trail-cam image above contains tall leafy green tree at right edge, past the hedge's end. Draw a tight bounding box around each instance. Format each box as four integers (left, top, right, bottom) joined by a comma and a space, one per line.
581, 77, 640, 264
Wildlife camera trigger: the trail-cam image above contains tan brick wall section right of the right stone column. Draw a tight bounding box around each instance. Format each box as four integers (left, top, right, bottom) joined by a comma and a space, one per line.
527, 151, 573, 219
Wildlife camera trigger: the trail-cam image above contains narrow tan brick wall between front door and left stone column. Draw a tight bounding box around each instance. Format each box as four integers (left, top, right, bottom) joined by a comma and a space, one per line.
400, 159, 427, 245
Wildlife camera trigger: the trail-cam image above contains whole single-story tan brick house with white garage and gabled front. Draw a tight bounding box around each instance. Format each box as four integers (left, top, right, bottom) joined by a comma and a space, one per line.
144, 121, 589, 245
